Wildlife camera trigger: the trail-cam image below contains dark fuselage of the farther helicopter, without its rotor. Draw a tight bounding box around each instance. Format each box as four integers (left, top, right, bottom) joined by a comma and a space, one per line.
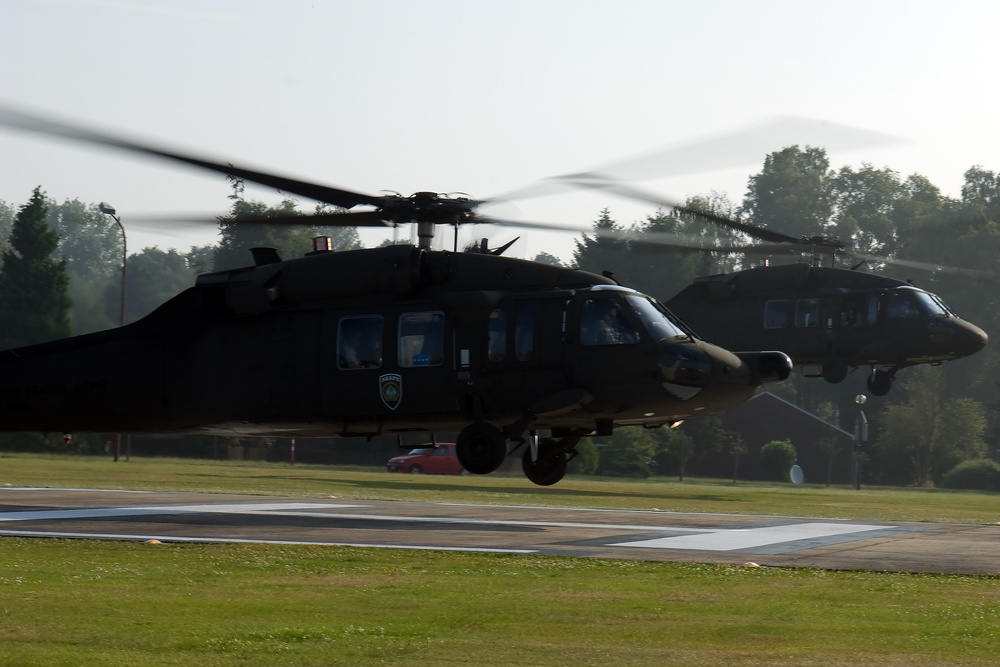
667, 264, 988, 368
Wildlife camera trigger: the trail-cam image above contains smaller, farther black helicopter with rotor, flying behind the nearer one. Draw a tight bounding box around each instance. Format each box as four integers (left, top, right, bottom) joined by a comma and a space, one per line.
561, 174, 995, 396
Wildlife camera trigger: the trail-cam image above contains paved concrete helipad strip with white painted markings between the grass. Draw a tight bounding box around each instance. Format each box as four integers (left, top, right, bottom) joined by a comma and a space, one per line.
0, 488, 1000, 574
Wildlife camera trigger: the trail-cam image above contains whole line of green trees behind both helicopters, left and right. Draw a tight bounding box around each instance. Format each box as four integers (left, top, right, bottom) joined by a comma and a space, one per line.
0, 146, 1000, 485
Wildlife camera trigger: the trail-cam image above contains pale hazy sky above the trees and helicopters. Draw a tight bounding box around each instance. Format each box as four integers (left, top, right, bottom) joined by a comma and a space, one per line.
0, 0, 1000, 259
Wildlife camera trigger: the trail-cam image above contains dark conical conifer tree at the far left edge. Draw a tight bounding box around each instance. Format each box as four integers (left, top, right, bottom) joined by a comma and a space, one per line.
0, 187, 71, 349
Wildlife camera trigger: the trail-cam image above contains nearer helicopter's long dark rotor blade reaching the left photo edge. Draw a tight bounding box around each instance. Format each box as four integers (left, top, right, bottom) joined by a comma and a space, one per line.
0, 106, 381, 208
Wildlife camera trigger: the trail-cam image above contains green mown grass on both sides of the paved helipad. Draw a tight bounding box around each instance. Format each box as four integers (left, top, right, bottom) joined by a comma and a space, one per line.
0, 455, 1000, 667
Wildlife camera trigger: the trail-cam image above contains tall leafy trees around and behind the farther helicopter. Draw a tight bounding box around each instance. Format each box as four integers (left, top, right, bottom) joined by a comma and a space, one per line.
574, 146, 1000, 489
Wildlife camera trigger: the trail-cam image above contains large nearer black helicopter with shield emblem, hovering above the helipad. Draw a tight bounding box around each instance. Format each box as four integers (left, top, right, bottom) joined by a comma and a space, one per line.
0, 111, 791, 485
